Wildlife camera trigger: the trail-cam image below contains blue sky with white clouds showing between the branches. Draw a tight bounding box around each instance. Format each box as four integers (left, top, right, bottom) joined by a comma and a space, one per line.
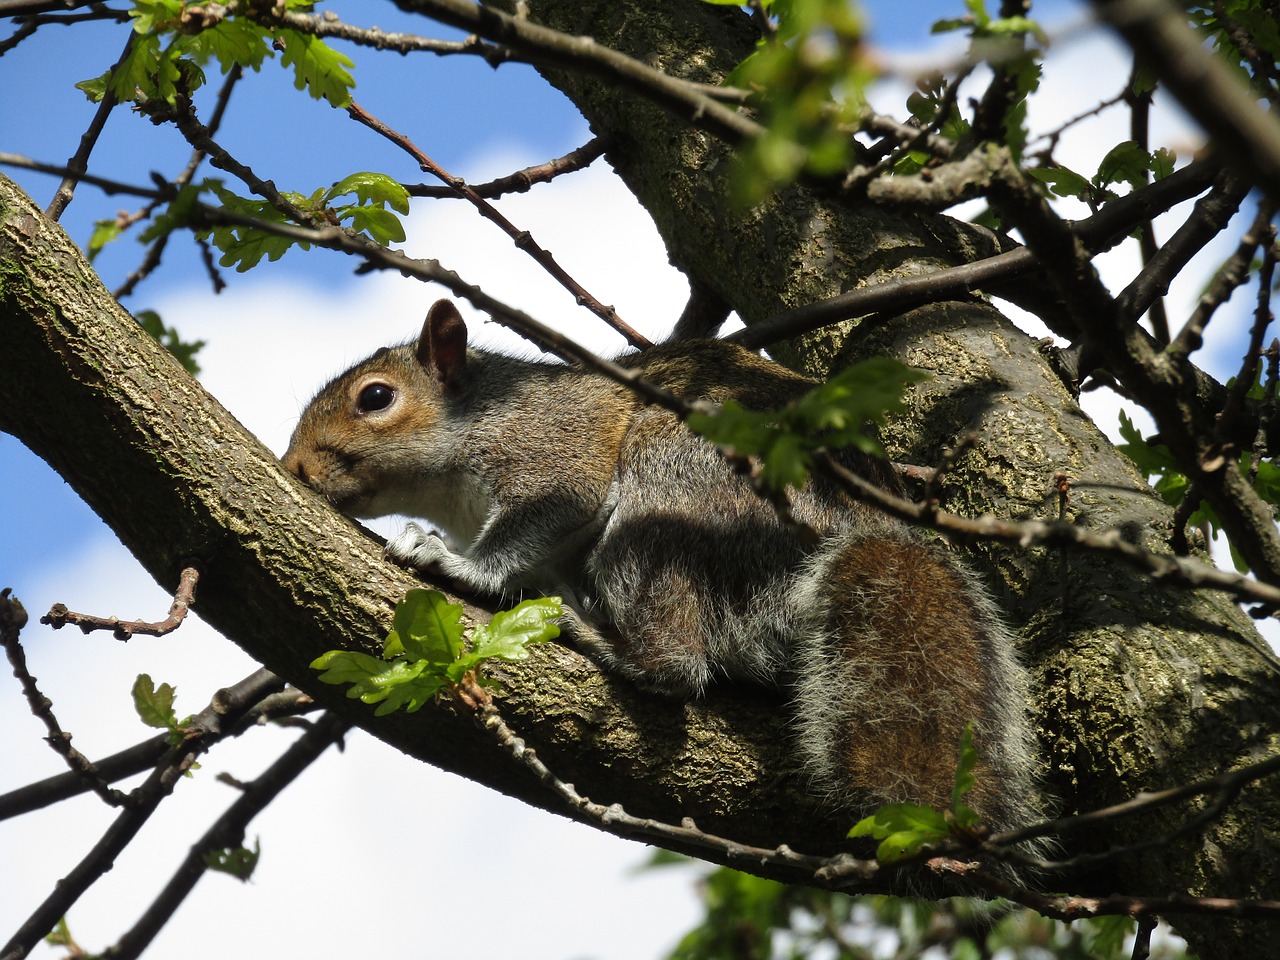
0, 0, 1259, 960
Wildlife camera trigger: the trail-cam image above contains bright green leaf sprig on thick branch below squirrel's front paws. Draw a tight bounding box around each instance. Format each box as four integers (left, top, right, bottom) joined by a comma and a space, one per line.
311, 590, 561, 717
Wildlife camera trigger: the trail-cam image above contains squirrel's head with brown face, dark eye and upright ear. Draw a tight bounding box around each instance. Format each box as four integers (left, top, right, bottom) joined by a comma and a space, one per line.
282, 300, 467, 517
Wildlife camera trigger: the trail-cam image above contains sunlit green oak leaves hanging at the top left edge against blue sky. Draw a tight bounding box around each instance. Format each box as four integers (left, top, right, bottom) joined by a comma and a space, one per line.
76, 0, 356, 106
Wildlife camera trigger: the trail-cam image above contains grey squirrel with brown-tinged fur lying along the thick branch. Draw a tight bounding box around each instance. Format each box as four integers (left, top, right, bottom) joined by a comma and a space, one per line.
284, 300, 1037, 827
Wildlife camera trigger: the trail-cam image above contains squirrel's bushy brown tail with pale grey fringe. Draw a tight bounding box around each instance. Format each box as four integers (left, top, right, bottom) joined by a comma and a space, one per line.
792, 521, 1039, 829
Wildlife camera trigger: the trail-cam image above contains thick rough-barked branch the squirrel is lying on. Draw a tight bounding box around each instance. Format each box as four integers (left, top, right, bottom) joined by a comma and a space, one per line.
0, 172, 921, 885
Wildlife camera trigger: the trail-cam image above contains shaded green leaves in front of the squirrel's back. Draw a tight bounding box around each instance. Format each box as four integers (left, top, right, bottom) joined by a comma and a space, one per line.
689, 357, 928, 490
